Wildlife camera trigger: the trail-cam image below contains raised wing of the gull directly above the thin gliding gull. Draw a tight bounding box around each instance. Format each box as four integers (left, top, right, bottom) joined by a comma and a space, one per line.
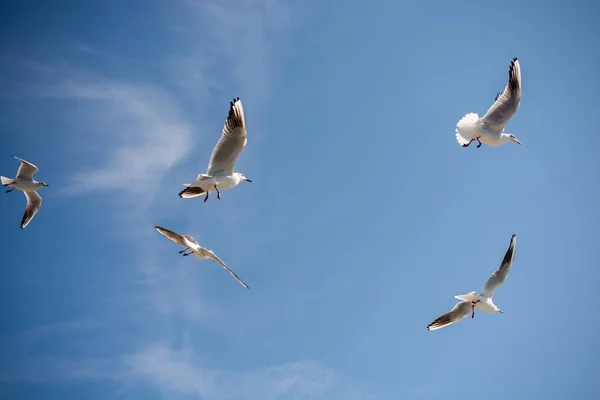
206, 97, 248, 176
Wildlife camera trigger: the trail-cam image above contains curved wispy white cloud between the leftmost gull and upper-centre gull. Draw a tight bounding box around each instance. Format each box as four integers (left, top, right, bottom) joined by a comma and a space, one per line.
39, 77, 193, 198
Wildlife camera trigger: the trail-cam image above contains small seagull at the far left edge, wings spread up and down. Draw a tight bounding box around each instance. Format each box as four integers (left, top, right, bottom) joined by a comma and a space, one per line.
0, 156, 48, 229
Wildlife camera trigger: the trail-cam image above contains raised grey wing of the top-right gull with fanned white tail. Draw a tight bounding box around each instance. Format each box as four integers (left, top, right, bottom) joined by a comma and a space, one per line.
481, 57, 522, 132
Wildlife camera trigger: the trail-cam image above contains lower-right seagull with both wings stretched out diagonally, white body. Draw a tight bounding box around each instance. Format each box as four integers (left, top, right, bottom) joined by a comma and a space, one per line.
427, 235, 517, 331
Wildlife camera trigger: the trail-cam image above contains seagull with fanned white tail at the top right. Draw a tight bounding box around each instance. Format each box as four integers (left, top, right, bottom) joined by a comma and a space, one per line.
456, 57, 523, 148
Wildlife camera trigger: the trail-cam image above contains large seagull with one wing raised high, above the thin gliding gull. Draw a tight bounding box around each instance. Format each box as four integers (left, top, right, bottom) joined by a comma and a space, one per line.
179, 97, 252, 203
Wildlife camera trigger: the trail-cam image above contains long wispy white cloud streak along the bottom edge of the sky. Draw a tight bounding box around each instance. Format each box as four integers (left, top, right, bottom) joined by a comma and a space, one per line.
1, 342, 368, 400
